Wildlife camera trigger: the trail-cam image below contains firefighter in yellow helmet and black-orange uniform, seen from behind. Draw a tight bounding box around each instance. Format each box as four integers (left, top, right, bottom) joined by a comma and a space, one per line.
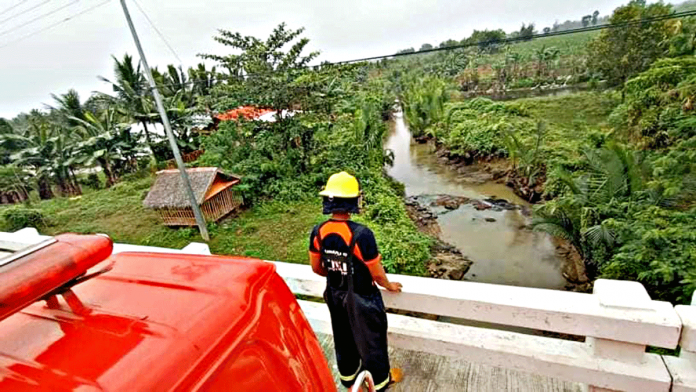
309, 172, 402, 391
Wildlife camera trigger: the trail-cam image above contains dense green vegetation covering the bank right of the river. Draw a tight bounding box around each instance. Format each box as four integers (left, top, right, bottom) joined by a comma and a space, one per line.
394, 1, 696, 303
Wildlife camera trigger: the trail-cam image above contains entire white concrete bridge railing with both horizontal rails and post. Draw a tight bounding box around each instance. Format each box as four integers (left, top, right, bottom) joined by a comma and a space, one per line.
0, 229, 696, 392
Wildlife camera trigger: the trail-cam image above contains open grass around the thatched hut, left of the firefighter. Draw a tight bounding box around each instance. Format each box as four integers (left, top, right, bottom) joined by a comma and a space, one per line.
0, 177, 323, 263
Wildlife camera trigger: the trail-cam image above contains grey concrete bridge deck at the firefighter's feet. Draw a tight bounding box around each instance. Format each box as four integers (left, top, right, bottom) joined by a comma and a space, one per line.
317, 333, 581, 392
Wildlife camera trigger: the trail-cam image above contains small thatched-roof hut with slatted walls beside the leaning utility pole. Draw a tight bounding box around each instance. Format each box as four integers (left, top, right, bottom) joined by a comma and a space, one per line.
143, 167, 241, 226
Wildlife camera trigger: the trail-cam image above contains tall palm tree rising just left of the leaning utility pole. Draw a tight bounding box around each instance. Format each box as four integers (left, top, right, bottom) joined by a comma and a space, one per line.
99, 54, 158, 151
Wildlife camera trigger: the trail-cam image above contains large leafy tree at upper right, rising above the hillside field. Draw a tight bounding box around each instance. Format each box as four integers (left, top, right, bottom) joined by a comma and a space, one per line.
589, 0, 676, 85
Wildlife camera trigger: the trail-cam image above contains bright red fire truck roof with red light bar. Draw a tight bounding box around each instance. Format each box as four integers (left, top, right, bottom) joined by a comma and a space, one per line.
0, 234, 369, 392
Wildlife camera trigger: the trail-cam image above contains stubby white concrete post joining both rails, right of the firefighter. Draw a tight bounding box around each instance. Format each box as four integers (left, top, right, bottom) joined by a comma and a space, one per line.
585, 279, 651, 392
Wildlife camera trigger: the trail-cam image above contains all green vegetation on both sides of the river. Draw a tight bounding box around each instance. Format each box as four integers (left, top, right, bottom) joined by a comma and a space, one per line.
0, 0, 696, 302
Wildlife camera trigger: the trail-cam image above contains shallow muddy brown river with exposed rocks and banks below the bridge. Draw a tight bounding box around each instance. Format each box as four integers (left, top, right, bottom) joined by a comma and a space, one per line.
387, 114, 582, 290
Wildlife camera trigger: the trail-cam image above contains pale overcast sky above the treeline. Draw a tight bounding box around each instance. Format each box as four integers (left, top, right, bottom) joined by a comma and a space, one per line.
0, 0, 626, 118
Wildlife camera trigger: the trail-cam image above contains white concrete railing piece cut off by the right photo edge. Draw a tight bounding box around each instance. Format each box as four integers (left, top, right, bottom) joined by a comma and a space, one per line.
662, 293, 696, 392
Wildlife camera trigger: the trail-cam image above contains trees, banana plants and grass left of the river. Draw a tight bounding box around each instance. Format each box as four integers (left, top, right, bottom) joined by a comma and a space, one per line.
0, 25, 431, 274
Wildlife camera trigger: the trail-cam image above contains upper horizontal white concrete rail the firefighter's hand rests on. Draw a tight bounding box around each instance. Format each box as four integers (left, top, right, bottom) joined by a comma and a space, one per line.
275, 262, 681, 348
